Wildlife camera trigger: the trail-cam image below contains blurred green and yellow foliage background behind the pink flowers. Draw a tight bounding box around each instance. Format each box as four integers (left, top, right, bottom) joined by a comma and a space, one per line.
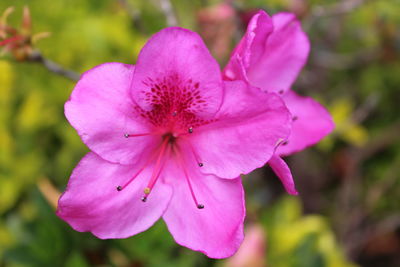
0, 0, 400, 267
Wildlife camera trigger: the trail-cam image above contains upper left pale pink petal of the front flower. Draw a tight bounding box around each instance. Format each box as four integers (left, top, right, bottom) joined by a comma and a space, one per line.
65, 63, 160, 164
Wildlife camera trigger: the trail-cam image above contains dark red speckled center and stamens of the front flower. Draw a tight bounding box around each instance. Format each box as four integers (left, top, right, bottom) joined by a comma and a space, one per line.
117, 75, 211, 209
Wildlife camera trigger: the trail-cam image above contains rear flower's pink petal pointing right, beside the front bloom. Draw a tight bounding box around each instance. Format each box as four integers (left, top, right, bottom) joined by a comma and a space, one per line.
277, 90, 334, 156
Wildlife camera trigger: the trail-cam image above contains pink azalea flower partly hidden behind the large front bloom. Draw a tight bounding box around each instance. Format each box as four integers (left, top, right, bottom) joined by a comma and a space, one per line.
223, 11, 334, 195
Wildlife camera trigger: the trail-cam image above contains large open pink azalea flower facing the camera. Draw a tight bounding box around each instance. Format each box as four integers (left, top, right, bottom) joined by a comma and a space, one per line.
57, 28, 291, 258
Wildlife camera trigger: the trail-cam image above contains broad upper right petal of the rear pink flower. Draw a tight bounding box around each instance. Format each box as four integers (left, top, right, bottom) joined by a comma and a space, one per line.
247, 13, 310, 92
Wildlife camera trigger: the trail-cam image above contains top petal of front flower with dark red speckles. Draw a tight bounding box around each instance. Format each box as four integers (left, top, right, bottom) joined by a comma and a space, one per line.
131, 28, 223, 117
